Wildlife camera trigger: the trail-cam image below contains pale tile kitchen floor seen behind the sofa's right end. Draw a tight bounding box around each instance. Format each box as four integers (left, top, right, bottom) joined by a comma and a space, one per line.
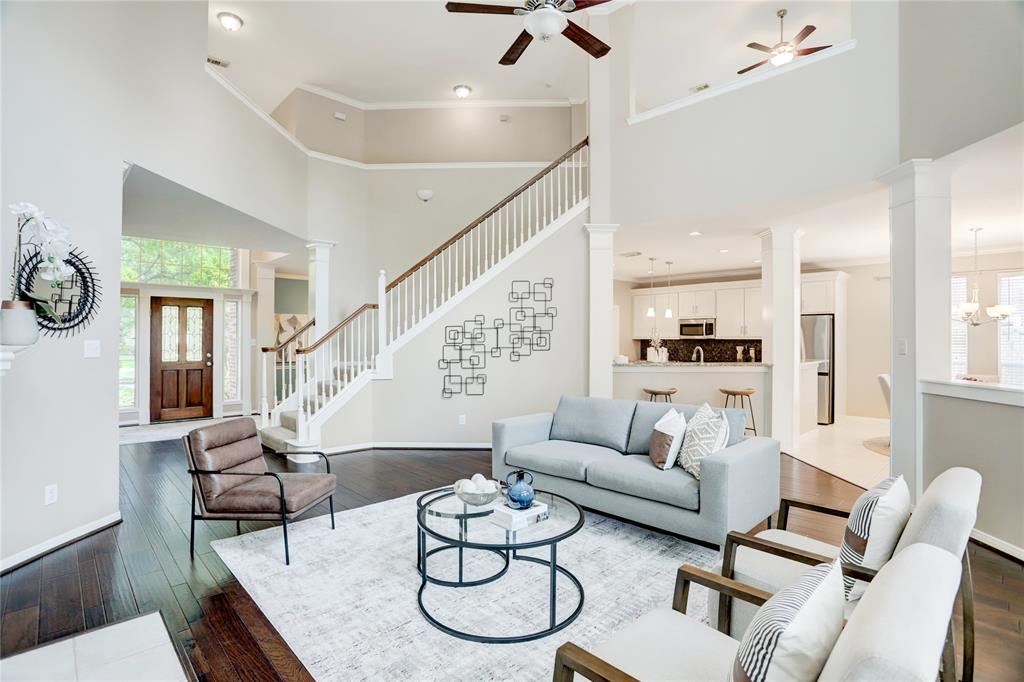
790, 417, 889, 488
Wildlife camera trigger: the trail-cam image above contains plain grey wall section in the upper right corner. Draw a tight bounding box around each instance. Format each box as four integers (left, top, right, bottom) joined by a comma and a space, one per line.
899, 0, 1024, 161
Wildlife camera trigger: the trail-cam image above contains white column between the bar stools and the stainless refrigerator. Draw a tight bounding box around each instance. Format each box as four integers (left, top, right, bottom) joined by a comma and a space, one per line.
759, 227, 801, 453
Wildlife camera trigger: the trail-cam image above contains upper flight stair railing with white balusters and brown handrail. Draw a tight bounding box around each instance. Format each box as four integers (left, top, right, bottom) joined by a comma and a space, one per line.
381, 138, 590, 345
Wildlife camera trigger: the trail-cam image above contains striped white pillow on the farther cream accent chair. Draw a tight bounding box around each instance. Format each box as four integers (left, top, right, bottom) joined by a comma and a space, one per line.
839, 476, 910, 601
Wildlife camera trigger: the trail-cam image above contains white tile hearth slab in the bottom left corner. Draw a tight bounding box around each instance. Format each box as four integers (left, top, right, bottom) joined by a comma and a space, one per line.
0, 613, 187, 682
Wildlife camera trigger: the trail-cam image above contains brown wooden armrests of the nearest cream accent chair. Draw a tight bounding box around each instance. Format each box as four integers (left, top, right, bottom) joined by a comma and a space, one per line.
552, 564, 771, 682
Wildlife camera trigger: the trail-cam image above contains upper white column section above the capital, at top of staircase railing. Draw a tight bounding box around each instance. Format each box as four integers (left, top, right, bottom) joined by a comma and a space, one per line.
587, 12, 611, 223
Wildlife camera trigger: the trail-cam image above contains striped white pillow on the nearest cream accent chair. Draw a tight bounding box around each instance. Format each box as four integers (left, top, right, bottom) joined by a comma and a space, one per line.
732, 560, 845, 682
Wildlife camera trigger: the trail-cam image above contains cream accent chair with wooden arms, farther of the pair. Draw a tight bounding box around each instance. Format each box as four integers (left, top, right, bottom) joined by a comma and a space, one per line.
708, 467, 981, 682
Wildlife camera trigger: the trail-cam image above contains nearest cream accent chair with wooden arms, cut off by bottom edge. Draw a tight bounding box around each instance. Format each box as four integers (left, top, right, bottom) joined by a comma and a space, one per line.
553, 543, 961, 682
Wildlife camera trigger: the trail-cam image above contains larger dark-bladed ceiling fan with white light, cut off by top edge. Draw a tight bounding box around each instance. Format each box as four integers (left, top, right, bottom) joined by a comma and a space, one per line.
444, 0, 611, 66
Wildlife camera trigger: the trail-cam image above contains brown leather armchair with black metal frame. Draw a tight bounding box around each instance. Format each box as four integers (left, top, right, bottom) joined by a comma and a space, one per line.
182, 417, 338, 564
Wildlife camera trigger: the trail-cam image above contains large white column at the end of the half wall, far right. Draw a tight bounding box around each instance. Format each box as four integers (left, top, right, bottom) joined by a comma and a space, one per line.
879, 159, 951, 499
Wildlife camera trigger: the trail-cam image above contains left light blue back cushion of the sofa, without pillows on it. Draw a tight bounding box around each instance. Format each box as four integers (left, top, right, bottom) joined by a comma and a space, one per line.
551, 395, 634, 453
